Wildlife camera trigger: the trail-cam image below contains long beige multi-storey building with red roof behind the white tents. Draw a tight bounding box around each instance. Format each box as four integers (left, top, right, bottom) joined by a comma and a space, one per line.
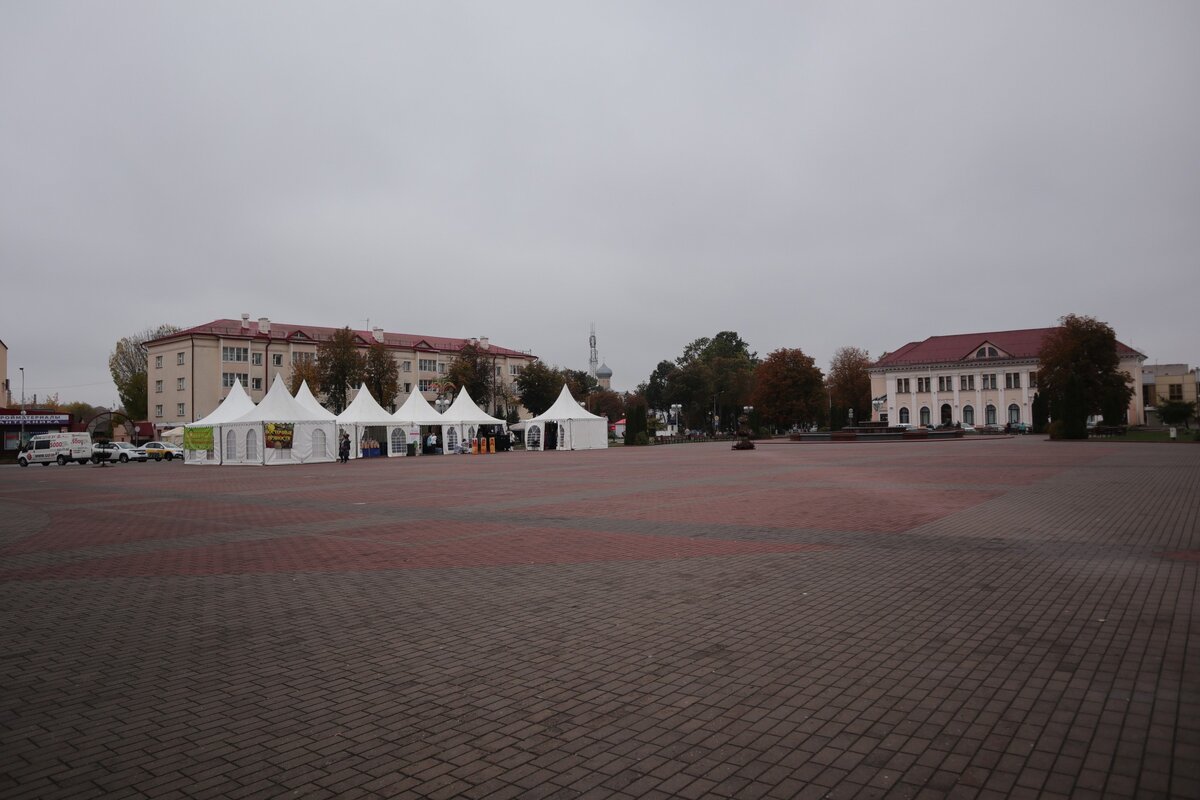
146, 315, 535, 427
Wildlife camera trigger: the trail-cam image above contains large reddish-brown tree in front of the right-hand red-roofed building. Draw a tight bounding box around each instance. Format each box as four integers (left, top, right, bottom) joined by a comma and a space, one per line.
1038, 314, 1134, 439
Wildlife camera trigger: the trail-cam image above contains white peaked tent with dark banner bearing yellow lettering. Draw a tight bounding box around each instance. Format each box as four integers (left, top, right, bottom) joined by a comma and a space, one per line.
222, 374, 337, 464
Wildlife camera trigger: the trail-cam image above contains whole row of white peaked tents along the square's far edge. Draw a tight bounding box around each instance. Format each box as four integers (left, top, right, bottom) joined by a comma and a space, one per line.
184, 375, 608, 465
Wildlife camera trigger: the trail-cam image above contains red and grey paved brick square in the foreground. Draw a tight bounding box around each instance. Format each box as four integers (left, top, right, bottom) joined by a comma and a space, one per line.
0, 437, 1200, 800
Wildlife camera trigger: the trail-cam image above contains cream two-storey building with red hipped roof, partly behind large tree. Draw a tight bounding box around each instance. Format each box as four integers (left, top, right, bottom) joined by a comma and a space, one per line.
870, 327, 1146, 426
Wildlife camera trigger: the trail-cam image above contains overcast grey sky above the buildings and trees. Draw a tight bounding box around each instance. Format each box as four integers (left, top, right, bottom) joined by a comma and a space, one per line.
0, 0, 1200, 404
